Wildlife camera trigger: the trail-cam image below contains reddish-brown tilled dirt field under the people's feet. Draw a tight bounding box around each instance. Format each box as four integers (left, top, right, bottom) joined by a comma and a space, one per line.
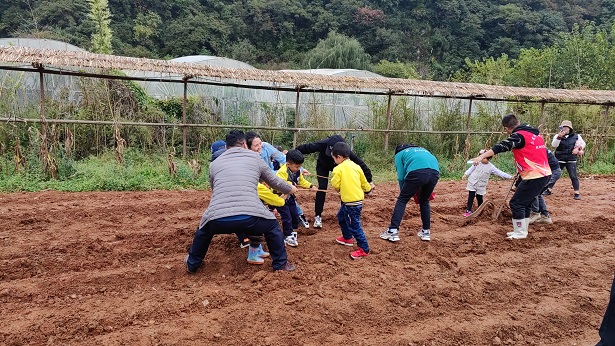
0, 177, 615, 346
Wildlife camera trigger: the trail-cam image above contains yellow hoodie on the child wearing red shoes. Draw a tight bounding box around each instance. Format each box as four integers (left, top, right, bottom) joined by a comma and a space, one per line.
331, 159, 372, 203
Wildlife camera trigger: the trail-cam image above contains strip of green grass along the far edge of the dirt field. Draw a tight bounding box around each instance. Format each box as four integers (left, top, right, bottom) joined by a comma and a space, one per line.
0, 149, 615, 192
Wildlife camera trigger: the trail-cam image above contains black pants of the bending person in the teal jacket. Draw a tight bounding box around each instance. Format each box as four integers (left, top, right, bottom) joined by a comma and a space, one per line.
389, 168, 440, 229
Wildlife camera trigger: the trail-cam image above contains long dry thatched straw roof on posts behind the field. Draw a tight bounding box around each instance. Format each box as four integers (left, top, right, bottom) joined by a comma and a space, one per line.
0, 46, 615, 104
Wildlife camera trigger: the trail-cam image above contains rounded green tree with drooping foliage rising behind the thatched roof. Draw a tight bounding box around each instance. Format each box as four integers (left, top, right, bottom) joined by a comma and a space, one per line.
303, 32, 370, 70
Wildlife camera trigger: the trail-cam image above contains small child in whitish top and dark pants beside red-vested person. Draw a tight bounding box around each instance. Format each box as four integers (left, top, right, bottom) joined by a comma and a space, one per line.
461, 149, 512, 217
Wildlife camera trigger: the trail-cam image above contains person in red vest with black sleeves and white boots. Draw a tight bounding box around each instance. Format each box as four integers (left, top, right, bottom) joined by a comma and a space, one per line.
472, 114, 551, 239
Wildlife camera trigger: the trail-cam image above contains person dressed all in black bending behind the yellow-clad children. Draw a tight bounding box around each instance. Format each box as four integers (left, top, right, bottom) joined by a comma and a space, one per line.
296, 135, 376, 228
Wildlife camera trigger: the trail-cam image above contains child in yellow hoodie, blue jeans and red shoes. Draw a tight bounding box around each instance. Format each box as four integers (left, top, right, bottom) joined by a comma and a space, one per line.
331, 142, 371, 259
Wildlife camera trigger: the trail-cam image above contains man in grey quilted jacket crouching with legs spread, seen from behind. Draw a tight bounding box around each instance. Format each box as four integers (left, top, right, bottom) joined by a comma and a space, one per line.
185, 130, 297, 273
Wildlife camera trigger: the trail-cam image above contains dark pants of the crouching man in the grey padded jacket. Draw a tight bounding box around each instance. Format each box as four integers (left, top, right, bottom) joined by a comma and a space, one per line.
188, 216, 286, 271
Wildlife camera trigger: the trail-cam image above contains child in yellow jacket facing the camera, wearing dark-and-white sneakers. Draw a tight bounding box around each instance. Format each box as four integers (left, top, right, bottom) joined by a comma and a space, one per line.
276, 150, 317, 247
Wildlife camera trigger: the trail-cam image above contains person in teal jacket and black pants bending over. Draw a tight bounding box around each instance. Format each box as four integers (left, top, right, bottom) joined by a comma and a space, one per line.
380, 144, 440, 242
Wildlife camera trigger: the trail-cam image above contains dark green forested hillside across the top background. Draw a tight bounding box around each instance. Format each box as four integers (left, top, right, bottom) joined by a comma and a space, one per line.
0, 0, 615, 80
